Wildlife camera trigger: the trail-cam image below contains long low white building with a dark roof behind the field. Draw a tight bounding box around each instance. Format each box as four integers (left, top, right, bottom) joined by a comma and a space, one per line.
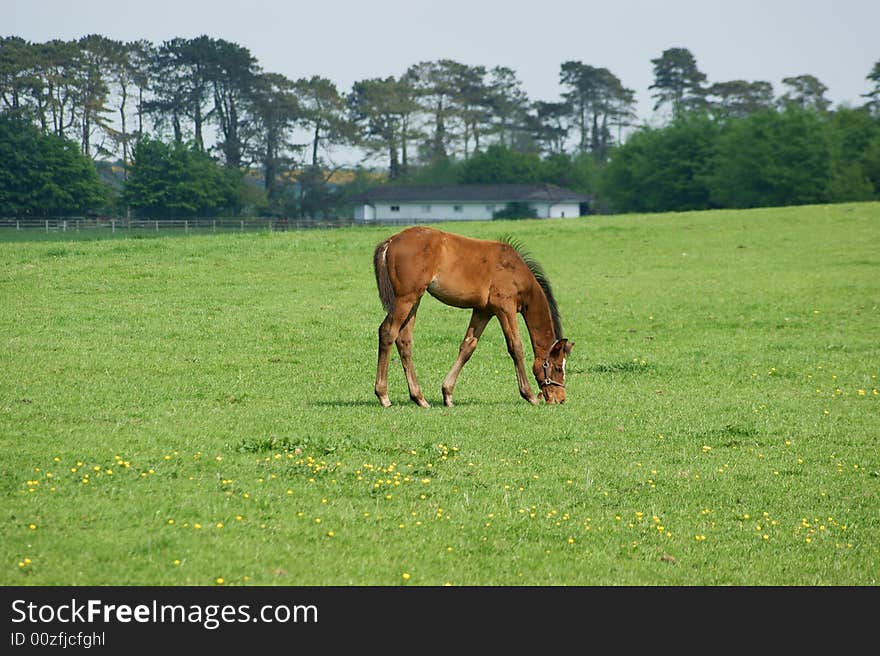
353, 184, 590, 223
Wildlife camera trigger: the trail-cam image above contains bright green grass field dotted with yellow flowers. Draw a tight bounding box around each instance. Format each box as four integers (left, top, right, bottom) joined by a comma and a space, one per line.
0, 203, 880, 586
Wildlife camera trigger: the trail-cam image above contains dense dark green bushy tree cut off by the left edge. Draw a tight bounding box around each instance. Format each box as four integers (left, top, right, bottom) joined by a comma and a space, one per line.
0, 112, 107, 216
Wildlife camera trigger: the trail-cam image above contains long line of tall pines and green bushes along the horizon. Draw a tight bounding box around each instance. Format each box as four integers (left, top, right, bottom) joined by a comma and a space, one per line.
0, 35, 880, 218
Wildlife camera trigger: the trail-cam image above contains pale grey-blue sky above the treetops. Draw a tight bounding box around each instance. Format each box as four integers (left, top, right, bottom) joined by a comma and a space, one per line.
0, 0, 880, 160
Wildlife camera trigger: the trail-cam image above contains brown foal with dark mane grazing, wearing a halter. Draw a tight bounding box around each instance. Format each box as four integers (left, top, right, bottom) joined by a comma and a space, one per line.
373, 226, 574, 408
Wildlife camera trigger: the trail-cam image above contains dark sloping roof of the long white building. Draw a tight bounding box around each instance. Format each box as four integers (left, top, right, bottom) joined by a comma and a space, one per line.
352, 184, 590, 203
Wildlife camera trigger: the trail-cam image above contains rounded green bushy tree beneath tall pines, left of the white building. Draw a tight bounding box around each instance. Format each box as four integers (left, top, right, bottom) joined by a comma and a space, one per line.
123, 137, 241, 219
